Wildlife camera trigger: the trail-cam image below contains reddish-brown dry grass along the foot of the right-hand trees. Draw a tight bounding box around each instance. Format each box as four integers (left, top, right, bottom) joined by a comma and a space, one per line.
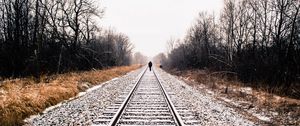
169, 70, 300, 125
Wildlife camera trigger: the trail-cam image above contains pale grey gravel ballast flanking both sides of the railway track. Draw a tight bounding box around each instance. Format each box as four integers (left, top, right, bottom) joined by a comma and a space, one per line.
26, 67, 255, 126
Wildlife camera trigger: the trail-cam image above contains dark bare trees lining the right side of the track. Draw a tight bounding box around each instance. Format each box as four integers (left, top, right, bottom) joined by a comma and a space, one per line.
162, 0, 300, 95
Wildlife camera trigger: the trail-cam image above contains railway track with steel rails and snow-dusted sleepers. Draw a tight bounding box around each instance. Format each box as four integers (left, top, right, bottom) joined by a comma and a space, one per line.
93, 68, 200, 126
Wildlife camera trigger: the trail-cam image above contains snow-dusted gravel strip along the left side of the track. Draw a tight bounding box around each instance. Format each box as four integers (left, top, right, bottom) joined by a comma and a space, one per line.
25, 68, 144, 126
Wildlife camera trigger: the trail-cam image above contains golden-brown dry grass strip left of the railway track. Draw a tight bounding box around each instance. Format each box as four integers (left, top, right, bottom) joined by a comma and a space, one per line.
0, 65, 140, 126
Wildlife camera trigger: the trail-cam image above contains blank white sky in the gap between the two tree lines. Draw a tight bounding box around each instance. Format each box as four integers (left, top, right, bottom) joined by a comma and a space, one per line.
99, 0, 223, 57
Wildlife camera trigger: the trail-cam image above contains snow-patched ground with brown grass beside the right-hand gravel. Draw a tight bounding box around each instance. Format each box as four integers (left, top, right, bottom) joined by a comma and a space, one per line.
161, 68, 300, 125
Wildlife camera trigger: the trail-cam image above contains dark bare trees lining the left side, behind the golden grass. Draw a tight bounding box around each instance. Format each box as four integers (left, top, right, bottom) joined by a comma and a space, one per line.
0, 0, 133, 77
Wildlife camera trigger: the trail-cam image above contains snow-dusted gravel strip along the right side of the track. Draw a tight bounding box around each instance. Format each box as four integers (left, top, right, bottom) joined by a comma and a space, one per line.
156, 69, 257, 126
